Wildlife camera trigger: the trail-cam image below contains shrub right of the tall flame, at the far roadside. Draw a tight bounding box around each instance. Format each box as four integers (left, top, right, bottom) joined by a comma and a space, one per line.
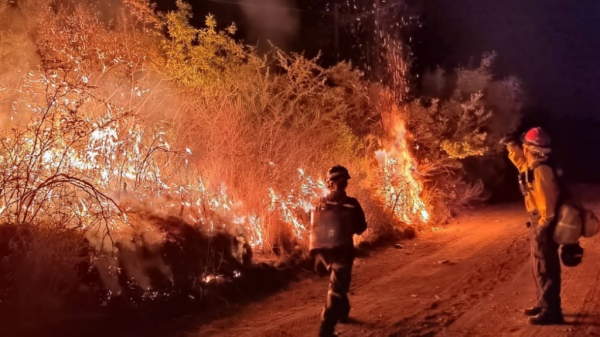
403, 53, 522, 222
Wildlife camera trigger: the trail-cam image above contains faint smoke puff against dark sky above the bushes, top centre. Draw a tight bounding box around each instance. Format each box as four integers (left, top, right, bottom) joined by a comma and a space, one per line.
239, 0, 299, 47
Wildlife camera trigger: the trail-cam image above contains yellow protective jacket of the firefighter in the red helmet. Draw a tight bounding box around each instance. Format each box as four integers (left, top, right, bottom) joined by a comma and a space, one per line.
507, 143, 560, 226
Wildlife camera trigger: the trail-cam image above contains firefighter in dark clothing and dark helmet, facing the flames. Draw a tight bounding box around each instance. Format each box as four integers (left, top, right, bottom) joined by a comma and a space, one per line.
311, 165, 367, 336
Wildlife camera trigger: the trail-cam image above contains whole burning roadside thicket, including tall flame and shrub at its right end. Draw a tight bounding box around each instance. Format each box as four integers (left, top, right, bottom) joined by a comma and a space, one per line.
0, 0, 518, 326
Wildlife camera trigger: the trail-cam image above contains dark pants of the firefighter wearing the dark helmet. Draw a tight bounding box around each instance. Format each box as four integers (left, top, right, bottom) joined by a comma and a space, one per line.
316, 251, 354, 333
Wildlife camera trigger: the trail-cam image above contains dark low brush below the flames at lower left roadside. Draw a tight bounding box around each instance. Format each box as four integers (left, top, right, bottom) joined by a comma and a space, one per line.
0, 213, 256, 329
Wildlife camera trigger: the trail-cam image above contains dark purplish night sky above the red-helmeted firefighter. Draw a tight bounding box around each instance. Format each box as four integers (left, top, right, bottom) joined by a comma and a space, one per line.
419, 0, 600, 120
